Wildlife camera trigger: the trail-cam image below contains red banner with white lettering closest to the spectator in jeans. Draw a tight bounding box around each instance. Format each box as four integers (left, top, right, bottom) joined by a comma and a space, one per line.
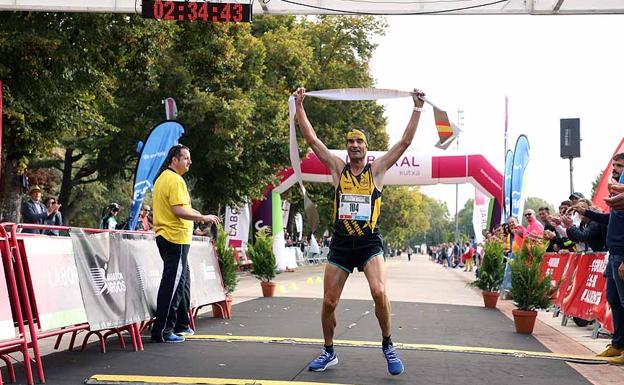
561, 253, 607, 320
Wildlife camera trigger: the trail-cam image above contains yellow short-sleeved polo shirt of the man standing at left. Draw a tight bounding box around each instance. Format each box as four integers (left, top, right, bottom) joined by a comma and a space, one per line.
153, 169, 193, 245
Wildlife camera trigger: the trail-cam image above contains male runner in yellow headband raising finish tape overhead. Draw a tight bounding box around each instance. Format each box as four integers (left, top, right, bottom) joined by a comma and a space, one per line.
295, 88, 424, 375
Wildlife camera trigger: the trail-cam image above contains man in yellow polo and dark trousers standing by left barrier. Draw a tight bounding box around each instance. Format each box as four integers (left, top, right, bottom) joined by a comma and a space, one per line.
152, 144, 220, 342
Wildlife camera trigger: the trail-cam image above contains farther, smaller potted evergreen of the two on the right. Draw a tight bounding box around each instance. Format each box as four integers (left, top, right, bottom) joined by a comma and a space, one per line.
469, 238, 505, 308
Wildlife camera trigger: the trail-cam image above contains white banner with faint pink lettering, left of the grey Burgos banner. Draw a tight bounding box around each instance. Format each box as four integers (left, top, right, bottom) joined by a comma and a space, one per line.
23, 237, 87, 330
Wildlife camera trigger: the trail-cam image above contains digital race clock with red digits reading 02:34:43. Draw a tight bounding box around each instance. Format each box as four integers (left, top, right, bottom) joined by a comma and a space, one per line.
142, 0, 251, 23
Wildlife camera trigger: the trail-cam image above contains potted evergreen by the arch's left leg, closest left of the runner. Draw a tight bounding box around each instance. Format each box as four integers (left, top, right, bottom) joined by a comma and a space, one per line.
247, 227, 277, 297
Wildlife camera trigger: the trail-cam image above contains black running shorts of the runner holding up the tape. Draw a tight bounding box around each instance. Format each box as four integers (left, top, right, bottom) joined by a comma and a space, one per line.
327, 234, 383, 273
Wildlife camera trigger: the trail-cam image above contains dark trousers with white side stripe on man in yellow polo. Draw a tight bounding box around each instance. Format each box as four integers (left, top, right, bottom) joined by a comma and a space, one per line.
152, 236, 191, 341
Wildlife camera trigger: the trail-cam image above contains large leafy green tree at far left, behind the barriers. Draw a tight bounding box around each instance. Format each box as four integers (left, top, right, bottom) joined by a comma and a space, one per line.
0, 12, 170, 220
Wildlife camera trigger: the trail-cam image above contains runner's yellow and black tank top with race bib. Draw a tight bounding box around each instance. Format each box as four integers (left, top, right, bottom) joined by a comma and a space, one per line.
334, 163, 381, 236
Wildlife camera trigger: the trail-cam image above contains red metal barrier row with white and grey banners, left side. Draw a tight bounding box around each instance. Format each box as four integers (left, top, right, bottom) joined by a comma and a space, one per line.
0, 223, 229, 385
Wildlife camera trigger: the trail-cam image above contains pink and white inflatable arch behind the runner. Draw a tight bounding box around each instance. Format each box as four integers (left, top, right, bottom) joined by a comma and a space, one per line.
252, 150, 503, 270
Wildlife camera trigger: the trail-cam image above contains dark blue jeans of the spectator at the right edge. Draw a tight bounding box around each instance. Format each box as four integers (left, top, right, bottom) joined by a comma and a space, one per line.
605, 254, 624, 349
